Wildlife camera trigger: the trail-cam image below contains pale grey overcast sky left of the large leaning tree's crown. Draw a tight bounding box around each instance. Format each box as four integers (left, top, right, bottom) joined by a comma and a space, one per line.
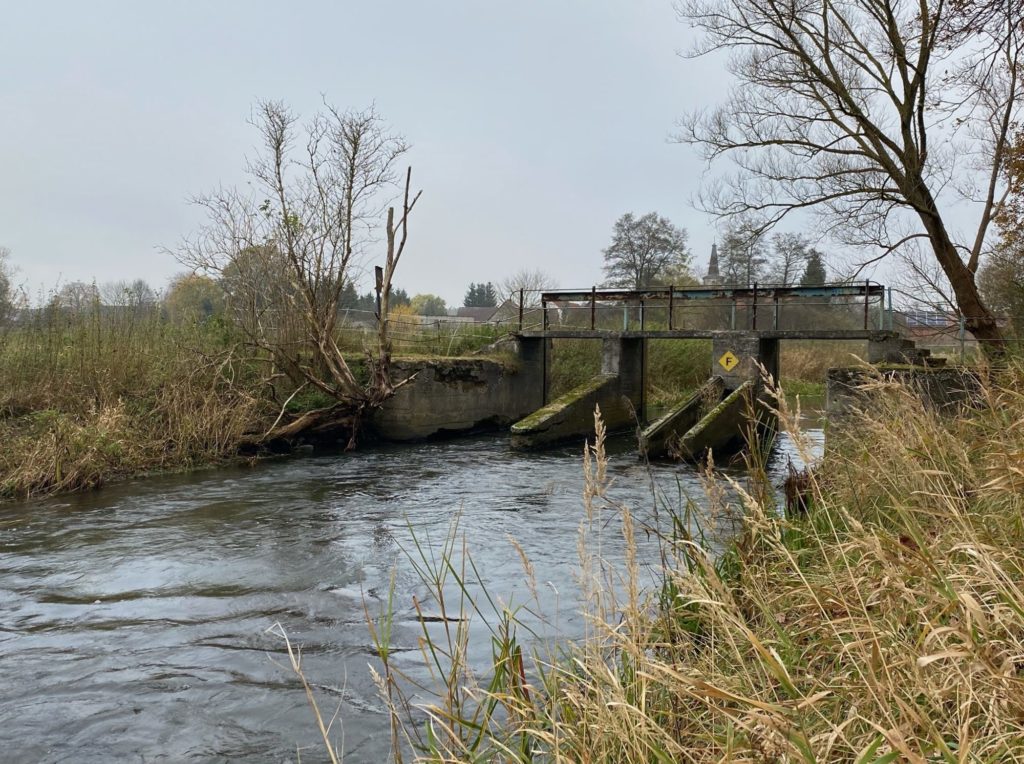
0, 0, 737, 301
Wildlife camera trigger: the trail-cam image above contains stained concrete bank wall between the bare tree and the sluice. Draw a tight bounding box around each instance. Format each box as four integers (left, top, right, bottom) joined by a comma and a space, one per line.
371, 358, 544, 440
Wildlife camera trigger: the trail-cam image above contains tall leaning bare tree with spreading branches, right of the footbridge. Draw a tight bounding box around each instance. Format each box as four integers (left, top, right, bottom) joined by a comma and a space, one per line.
677, 0, 1024, 353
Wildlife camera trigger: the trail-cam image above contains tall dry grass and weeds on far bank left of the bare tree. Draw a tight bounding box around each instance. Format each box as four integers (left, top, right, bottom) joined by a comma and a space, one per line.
0, 304, 270, 499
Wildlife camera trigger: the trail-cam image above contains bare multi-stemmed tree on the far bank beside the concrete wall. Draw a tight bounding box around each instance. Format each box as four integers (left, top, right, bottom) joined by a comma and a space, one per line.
175, 101, 419, 442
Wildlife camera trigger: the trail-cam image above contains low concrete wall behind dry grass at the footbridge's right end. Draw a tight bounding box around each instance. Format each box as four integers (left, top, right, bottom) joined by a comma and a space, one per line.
825, 366, 980, 415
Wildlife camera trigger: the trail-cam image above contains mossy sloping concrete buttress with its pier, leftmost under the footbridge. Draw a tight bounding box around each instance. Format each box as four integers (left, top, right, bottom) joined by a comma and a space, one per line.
512, 338, 645, 450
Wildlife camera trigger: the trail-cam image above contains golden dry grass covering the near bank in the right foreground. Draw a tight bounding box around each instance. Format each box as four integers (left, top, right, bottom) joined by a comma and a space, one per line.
354, 360, 1024, 764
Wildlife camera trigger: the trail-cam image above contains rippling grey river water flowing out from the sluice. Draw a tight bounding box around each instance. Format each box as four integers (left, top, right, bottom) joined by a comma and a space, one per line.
0, 419, 821, 762
